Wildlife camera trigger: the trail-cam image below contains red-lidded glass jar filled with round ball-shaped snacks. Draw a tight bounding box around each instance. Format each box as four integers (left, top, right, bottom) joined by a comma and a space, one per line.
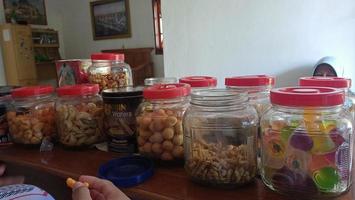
137, 83, 191, 163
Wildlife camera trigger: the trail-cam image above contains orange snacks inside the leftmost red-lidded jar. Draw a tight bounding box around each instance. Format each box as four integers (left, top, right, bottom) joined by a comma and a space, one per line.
6, 103, 56, 144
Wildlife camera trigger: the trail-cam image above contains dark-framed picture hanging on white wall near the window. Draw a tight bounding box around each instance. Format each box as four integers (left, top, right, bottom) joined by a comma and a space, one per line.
90, 0, 131, 40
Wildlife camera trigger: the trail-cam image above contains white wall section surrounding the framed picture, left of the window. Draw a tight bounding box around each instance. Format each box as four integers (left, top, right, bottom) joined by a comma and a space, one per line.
63, 0, 164, 76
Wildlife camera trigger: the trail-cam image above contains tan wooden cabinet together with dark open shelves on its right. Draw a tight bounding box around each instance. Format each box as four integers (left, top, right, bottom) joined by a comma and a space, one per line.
0, 24, 60, 85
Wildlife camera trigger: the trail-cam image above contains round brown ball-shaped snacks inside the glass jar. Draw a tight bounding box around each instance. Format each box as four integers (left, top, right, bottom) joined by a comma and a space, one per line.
137, 109, 184, 160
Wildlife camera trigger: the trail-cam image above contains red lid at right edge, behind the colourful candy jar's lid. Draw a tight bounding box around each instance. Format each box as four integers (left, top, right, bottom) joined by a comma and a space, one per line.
299, 76, 351, 88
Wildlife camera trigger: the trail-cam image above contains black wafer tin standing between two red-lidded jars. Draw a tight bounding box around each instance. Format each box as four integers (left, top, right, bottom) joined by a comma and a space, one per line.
102, 87, 143, 153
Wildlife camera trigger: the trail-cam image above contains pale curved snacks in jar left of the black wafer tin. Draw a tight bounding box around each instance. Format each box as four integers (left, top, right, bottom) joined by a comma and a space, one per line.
57, 103, 103, 146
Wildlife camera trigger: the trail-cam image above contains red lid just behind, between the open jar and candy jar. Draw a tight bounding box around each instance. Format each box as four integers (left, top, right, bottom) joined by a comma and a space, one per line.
225, 75, 275, 86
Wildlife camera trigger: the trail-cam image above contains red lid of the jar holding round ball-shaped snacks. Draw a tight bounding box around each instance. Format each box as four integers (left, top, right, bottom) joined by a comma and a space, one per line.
143, 83, 191, 99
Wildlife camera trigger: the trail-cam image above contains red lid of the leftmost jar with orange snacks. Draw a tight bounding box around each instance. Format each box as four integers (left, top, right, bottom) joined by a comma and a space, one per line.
11, 85, 54, 98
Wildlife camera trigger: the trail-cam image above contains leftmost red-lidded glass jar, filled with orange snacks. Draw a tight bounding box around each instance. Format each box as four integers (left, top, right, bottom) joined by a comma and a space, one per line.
6, 86, 56, 145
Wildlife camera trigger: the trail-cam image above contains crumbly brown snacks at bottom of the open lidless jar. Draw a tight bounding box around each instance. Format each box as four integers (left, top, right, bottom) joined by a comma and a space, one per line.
185, 141, 256, 184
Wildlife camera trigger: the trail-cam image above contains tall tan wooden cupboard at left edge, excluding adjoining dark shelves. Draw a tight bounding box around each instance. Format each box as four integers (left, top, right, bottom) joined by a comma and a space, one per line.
0, 24, 37, 85
